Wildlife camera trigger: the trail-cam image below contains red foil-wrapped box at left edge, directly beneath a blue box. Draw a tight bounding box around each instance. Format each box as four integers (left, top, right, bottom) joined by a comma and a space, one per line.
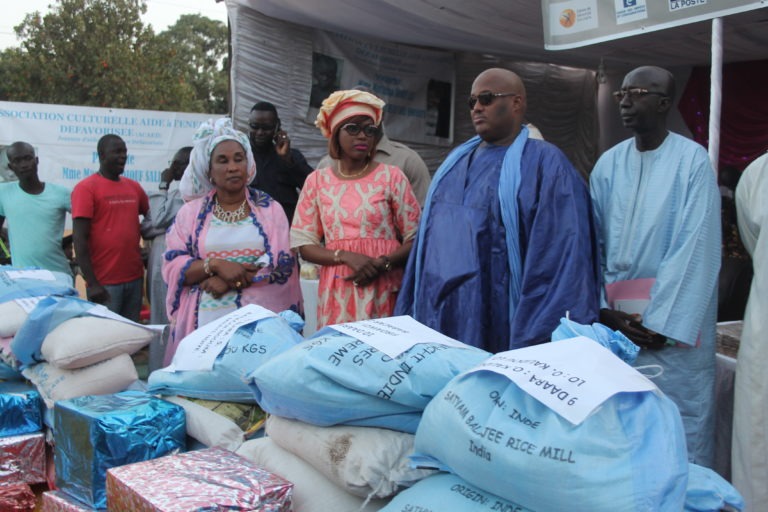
0, 432, 46, 484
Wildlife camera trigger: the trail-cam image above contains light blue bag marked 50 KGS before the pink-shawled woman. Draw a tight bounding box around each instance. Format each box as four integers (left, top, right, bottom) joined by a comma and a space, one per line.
148, 311, 304, 403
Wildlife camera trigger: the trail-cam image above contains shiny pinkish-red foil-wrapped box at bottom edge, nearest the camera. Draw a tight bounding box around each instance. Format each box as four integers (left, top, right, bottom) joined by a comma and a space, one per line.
107, 448, 293, 512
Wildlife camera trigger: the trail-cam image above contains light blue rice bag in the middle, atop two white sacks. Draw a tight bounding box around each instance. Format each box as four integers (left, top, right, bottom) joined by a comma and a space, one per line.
249, 329, 490, 433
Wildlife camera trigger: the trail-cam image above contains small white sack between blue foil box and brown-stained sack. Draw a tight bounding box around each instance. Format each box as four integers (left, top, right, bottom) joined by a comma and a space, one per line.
163, 396, 245, 452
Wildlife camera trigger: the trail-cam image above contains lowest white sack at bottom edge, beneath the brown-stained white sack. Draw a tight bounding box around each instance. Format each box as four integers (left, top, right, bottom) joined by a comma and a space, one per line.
236, 437, 387, 512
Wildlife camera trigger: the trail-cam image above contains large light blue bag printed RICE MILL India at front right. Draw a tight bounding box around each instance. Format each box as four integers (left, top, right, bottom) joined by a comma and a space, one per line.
412, 322, 688, 512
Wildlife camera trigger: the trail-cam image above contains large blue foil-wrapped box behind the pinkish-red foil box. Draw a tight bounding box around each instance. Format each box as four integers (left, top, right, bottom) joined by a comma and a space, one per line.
54, 391, 186, 508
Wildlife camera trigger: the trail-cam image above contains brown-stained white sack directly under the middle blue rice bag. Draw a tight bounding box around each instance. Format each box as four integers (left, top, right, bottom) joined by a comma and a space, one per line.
266, 415, 435, 498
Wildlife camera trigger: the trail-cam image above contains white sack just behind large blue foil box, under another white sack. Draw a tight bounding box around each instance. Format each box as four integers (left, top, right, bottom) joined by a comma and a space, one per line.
22, 354, 138, 408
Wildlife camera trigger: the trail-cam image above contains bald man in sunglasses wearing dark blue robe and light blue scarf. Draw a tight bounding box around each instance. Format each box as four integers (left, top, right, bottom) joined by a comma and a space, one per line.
395, 69, 599, 352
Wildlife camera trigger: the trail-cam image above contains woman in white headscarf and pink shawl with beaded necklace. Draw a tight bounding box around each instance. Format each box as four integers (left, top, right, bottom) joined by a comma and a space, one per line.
163, 118, 301, 364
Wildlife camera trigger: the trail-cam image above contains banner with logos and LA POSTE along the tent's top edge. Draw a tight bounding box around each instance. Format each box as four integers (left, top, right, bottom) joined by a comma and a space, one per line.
541, 0, 765, 50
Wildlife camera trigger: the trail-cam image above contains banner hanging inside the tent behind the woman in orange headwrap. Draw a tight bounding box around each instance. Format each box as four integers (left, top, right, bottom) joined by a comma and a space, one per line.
307, 30, 456, 146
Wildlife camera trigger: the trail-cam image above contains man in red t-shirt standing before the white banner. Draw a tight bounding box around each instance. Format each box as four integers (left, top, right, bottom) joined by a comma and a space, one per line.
72, 134, 149, 321
